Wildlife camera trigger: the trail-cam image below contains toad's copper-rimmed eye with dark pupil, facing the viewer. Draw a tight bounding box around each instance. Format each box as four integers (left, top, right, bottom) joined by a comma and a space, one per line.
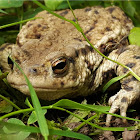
52, 58, 68, 74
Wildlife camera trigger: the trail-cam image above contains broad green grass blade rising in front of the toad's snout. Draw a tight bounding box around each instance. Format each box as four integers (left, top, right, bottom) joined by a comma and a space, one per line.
9, 56, 49, 140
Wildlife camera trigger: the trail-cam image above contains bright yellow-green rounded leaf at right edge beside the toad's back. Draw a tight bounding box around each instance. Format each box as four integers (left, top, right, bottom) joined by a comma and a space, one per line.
128, 27, 140, 46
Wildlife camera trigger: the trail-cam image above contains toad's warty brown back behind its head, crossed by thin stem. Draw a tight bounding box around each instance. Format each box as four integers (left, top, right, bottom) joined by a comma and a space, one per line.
17, 7, 132, 50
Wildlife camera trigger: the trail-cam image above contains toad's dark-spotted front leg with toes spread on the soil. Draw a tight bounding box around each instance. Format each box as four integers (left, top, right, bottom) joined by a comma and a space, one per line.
106, 45, 140, 126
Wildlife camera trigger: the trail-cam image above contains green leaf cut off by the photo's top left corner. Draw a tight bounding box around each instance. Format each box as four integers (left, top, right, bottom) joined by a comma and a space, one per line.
0, 0, 23, 9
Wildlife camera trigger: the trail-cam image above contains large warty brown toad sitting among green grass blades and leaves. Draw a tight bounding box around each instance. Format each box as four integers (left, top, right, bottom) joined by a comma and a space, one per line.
0, 7, 140, 125
